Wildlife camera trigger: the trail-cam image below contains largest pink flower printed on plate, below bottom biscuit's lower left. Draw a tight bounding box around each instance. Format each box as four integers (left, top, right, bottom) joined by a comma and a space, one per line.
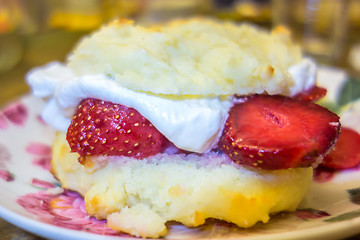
17, 184, 124, 236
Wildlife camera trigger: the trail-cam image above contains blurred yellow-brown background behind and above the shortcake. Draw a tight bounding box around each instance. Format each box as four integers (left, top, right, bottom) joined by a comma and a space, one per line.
0, 0, 360, 106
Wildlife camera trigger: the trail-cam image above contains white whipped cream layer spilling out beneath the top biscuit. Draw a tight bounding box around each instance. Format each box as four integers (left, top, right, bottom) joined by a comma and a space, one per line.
26, 59, 316, 153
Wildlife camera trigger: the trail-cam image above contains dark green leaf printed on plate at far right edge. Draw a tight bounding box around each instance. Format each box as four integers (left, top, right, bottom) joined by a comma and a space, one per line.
338, 77, 360, 106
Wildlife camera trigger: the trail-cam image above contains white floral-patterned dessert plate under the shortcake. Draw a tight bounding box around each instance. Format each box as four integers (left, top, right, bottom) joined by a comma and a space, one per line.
0, 68, 360, 240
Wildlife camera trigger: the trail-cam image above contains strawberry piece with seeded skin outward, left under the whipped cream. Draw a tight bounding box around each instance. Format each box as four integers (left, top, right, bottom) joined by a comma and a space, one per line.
66, 98, 168, 162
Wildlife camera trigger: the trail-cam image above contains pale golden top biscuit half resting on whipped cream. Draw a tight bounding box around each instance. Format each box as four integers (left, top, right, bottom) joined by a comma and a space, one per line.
68, 18, 302, 96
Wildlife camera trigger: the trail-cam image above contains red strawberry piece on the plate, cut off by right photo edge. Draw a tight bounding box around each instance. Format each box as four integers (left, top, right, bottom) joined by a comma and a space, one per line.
321, 127, 360, 170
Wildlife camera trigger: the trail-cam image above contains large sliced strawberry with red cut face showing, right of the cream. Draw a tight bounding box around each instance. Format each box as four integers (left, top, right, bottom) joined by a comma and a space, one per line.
220, 95, 340, 170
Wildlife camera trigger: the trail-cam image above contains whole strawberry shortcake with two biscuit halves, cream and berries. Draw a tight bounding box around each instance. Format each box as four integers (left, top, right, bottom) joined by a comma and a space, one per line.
27, 18, 340, 238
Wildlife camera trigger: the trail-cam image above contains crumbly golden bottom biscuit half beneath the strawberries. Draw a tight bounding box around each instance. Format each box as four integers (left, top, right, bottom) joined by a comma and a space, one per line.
52, 133, 312, 238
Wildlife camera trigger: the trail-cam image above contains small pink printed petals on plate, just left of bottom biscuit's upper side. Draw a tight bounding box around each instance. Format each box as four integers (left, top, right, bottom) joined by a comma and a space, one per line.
25, 143, 51, 170
